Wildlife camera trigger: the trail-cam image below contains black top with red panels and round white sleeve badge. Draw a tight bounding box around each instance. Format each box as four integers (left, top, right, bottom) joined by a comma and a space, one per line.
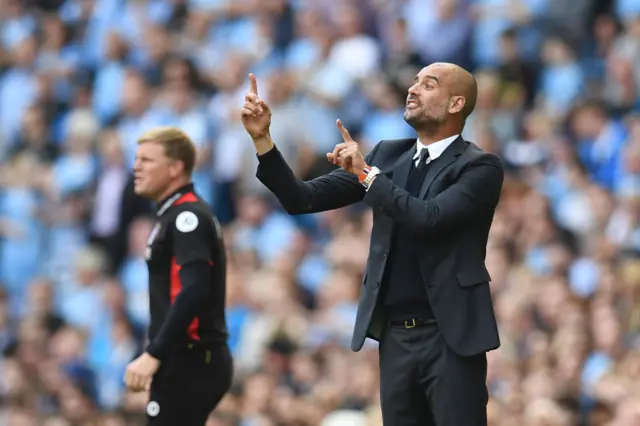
146, 184, 228, 360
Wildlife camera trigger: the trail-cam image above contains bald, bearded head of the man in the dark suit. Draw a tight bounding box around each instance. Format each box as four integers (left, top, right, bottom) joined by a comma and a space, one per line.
404, 62, 478, 133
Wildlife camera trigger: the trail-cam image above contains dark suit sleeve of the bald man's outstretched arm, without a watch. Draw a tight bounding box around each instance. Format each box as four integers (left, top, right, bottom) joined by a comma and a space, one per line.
256, 143, 380, 215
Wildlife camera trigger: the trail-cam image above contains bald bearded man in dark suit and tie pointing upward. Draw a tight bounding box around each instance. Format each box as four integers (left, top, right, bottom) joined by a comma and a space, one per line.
241, 63, 504, 426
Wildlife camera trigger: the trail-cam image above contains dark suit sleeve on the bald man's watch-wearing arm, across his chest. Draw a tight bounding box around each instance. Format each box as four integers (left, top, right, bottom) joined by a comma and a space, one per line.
363, 154, 504, 235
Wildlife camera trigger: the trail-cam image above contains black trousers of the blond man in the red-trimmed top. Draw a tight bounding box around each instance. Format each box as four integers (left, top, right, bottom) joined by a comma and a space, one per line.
147, 345, 233, 426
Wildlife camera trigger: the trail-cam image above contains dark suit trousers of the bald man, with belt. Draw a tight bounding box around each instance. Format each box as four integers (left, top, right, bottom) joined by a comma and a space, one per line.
379, 320, 488, 426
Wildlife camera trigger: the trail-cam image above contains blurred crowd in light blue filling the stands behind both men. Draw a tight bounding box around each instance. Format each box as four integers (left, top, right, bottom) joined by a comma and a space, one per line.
0, 0, 640, 426
